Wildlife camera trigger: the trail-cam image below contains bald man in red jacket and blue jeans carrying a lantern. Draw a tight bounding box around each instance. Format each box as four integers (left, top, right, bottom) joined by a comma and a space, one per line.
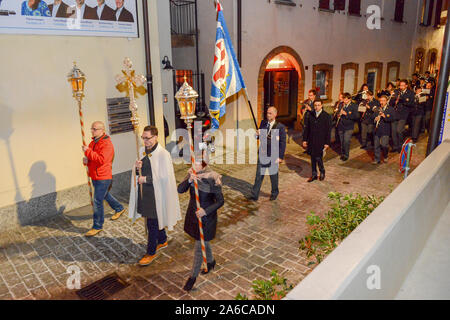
82, 121, 125, 237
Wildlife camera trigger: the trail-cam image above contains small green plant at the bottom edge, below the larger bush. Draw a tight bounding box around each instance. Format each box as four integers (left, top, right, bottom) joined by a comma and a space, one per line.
235, 270, 293, 300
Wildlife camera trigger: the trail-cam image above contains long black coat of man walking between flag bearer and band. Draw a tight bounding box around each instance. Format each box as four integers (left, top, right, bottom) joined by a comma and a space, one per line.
303, 110, 331, 157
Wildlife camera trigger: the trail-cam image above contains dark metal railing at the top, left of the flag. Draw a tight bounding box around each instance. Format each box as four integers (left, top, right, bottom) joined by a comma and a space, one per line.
170, 0, 197, 35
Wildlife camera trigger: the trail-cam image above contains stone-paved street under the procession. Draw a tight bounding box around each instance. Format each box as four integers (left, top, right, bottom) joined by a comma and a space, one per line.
0, 131, 427, 300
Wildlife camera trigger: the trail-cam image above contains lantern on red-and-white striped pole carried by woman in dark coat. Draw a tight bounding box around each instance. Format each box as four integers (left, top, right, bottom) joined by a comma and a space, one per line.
175, 75, 208, 271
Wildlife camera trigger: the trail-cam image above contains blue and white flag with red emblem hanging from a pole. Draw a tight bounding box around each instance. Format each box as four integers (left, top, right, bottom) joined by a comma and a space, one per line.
209, 1, 245, 131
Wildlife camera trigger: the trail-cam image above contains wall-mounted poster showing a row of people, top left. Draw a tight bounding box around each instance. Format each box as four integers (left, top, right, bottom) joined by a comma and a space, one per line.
0, 0, 139, 38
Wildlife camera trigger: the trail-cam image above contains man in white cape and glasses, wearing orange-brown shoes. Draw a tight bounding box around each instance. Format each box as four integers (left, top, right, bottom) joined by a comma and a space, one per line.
128, 126, 181, 266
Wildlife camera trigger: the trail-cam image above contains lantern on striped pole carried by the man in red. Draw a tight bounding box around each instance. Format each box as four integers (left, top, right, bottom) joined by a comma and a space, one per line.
67, 62, 94, 207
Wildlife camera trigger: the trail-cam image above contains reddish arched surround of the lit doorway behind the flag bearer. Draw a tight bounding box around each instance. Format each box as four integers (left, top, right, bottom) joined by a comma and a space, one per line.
257, 46, 305, 123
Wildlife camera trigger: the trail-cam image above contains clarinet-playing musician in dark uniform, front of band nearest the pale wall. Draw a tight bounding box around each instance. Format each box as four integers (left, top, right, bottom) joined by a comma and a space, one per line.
373, 95, 395, 164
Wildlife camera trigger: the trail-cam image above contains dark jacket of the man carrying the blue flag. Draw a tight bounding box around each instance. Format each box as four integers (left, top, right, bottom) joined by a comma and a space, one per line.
258, 120, 286, 167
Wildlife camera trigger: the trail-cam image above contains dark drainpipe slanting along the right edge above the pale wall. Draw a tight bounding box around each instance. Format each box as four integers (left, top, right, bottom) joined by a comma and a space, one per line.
427, 16, 450, 156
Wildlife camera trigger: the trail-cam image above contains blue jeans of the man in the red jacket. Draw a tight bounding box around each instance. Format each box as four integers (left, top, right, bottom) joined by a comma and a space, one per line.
92, 180, 124, 230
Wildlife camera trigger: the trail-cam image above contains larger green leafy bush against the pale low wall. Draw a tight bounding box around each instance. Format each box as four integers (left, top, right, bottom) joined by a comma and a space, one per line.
299, 192, 384, 263
